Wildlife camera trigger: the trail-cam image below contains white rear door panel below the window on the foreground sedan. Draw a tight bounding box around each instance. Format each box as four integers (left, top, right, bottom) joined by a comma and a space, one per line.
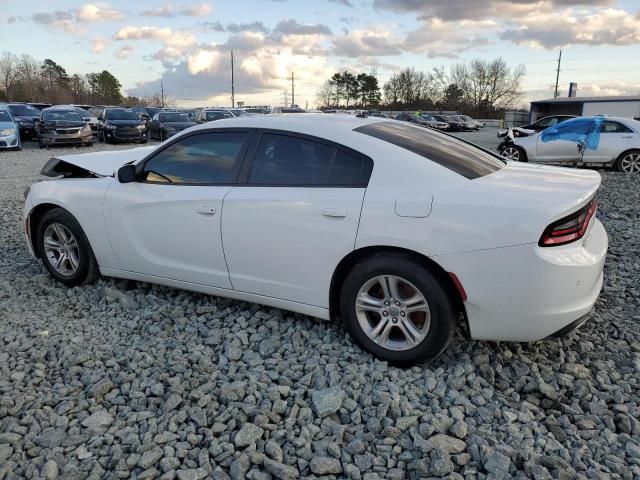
222, 186, 364, 308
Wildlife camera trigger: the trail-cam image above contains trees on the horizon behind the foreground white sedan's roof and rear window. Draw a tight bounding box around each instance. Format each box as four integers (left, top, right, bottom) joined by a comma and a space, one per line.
317, 58, 525, 118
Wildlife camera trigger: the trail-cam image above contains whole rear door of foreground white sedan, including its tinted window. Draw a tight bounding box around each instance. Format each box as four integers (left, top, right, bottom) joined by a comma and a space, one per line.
222, 132, 373, 308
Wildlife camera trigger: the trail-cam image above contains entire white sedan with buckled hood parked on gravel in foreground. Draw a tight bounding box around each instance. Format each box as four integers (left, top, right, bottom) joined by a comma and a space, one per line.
24, 114, 607, 365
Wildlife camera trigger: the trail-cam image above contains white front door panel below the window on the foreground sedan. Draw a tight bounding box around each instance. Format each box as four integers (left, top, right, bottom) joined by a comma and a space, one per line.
104, 181, 231, 288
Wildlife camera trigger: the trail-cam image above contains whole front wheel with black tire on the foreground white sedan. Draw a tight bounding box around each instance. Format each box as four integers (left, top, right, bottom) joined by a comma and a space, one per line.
36, 208, 99, 287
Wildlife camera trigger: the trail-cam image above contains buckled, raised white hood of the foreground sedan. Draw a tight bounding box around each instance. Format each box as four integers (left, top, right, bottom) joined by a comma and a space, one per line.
40, 146, 155, 177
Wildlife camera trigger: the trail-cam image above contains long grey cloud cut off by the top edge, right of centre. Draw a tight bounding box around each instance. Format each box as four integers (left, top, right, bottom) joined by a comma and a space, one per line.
373, 0, 616, 20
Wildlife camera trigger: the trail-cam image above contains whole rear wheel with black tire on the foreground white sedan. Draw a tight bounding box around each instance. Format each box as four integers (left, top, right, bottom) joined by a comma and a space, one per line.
340, 253, 456, 367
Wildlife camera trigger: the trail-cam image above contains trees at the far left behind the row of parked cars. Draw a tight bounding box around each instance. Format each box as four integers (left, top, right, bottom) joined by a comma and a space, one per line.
0, 52, 161, 106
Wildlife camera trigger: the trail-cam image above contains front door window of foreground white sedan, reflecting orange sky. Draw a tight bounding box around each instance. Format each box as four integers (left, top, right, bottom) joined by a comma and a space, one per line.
142, 132, 247, 184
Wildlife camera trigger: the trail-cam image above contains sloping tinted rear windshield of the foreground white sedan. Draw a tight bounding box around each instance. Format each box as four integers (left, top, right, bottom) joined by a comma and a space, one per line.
355, 122, 504, 179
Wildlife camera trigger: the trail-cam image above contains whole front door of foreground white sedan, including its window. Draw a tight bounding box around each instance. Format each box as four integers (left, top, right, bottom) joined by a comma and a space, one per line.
105, 130, 251, 288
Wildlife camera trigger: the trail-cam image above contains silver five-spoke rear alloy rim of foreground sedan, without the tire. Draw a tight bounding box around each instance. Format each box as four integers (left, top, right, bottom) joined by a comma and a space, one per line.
355, 275, 431, 351
